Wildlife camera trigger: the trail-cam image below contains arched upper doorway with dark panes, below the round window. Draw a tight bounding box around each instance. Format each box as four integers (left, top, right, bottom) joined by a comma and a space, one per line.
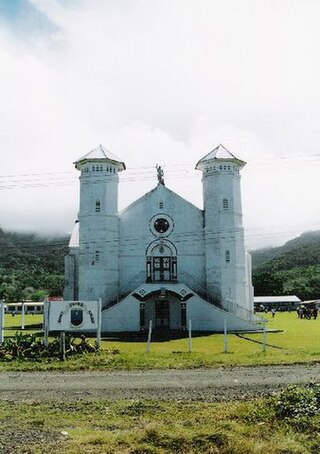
146, 239, 177, 282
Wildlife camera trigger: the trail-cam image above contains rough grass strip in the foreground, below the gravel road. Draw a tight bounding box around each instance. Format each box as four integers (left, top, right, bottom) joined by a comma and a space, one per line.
0, 397, 320, 454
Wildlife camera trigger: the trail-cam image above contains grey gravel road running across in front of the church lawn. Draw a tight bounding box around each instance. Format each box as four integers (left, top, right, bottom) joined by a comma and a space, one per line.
0, 364, 320, 402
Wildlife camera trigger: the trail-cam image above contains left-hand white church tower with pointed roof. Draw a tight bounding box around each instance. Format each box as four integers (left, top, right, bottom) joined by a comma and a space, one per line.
74, 145, 125, 303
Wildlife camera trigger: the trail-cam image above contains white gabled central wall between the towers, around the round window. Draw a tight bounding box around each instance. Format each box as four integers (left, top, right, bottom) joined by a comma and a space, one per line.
119, 184, 205, 289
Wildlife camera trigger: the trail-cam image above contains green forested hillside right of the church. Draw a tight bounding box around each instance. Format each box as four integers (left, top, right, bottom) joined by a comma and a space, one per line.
251, 231, 320, 300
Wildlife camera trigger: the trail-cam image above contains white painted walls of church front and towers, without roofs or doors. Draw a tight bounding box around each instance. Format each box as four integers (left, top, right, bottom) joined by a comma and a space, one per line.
65, 151, 253, 331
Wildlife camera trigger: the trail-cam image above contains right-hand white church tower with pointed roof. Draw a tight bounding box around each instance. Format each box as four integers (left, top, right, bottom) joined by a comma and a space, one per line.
196, 144, 253, 310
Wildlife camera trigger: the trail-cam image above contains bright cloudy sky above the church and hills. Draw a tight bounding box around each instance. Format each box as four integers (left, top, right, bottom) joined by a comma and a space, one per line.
0, 0, 320, 248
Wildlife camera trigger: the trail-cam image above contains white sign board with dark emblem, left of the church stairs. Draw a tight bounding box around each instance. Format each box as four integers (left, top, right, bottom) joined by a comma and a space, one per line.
47, 301, 101, 332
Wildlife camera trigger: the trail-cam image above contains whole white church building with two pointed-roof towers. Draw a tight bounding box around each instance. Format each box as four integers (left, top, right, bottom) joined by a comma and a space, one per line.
64, 145, 259, 334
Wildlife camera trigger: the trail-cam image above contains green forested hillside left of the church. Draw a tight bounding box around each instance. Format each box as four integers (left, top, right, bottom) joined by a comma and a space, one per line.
0, 229, 69, 302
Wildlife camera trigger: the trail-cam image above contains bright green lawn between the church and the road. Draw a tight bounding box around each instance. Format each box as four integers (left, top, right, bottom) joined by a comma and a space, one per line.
0, 313, 320, 370
